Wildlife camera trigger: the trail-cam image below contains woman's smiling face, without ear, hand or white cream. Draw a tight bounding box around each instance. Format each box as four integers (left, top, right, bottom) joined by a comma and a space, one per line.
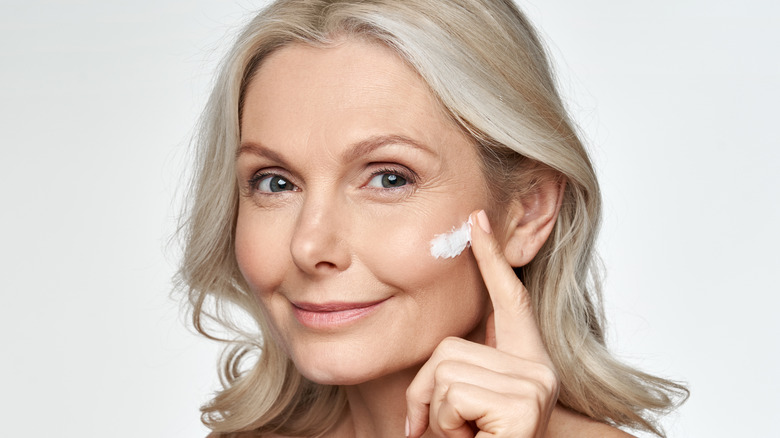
236, 39, 500, 384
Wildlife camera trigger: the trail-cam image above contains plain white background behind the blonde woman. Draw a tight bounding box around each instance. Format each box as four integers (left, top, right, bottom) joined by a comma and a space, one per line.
0, 0, 780, 437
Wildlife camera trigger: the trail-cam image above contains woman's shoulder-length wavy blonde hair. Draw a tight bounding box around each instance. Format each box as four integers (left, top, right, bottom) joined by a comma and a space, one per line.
178, 0, 687, 436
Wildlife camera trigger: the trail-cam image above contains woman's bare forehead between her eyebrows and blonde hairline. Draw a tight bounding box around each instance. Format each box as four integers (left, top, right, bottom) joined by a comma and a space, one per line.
241, 38, 464, 156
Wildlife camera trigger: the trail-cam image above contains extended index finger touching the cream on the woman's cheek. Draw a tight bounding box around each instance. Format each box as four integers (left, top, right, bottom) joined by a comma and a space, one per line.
471, 210, 551, 364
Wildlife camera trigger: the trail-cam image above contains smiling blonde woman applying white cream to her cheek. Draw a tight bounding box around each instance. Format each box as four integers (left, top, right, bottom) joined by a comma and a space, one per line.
180, 0, 685, 437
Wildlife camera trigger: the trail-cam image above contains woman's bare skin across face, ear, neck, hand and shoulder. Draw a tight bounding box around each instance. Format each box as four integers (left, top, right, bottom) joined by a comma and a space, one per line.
236, 39, 627, 437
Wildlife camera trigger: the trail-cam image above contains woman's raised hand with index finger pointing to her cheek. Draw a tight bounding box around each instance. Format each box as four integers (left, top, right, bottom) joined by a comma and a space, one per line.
406, 211, 558, 438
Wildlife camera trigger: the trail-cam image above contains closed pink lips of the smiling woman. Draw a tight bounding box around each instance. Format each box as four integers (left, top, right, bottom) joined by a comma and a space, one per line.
292, 298, 387, 329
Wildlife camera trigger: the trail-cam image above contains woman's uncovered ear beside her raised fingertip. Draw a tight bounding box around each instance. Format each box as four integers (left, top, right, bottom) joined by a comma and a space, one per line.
504, 178, 566, 268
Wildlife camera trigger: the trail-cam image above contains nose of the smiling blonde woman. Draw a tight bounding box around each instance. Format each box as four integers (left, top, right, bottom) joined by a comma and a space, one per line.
290, 193, 352, 276
